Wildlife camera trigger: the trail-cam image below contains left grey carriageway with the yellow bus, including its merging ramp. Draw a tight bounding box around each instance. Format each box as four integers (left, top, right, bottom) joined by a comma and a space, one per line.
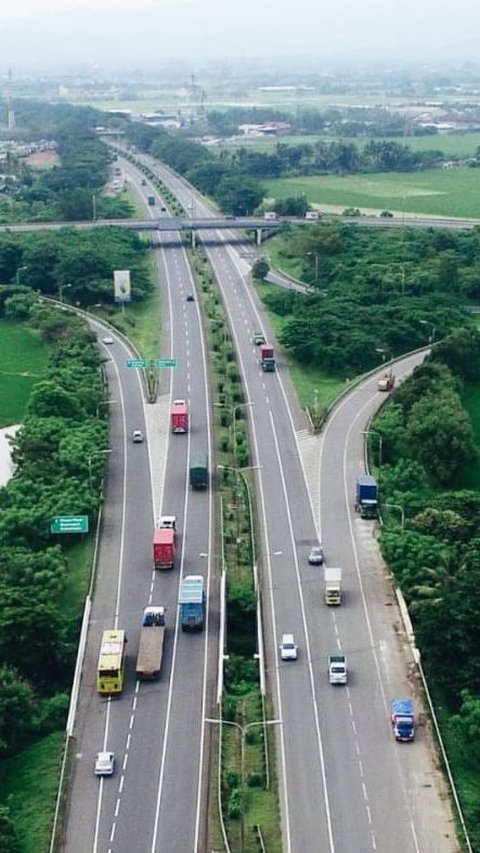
64, 176, 215, 853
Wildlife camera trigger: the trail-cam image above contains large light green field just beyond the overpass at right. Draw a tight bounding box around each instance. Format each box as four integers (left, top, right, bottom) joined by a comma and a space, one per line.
262, 167, 480, 219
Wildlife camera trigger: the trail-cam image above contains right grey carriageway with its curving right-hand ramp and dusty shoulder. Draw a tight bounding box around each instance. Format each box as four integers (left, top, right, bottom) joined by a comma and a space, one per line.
128, 150, 455, 853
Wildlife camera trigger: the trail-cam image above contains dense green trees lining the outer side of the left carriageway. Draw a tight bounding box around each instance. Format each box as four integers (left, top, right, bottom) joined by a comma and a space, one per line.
0, 286, 108, 853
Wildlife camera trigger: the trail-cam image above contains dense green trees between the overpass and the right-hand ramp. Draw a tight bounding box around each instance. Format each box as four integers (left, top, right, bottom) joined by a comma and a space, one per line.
260, 224, 480, 377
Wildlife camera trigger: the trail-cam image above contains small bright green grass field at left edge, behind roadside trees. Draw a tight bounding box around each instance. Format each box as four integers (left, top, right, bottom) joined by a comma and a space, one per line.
0, 319, 48, 427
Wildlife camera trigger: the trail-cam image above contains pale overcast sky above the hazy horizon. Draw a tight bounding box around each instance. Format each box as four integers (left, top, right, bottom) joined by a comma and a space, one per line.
0, 0, 480, 70
